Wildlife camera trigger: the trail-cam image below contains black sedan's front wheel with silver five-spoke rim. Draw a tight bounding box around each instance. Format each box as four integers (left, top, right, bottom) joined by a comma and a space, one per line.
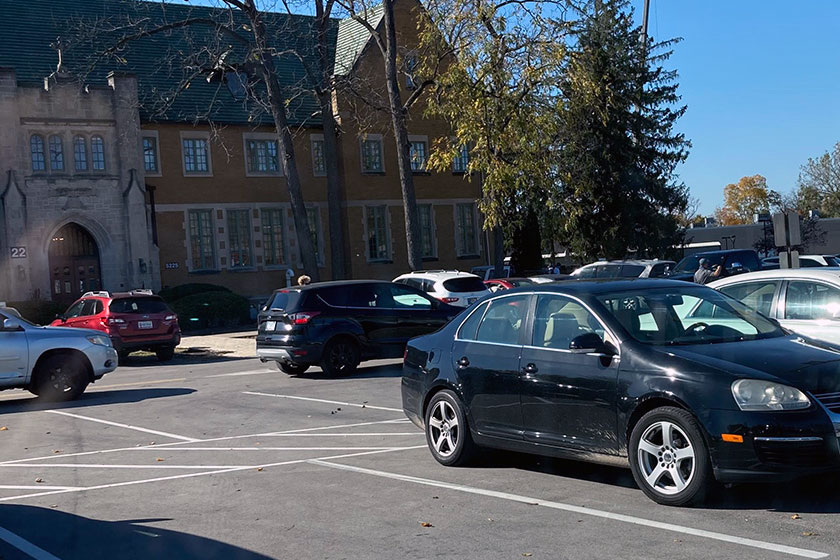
628, 406, 711, 506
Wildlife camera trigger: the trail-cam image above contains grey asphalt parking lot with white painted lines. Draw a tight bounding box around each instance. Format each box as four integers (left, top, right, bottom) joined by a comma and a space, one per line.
0, 357, 840, 560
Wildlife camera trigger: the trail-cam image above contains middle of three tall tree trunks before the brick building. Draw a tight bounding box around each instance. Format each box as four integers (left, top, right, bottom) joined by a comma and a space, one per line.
315, 1, 348, 280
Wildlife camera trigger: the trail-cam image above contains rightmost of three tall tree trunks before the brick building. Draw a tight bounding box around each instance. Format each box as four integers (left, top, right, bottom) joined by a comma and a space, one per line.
383, 0, 423, 270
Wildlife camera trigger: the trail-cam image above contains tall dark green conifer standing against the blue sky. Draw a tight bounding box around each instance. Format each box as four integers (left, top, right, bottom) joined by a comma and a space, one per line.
557, 0, 690, 259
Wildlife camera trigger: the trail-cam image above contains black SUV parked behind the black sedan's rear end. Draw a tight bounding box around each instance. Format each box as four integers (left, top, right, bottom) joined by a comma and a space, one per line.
257, 280, 461, 375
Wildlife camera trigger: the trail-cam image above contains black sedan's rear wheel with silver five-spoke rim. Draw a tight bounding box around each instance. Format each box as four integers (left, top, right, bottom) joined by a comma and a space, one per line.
426, 389, 476, 467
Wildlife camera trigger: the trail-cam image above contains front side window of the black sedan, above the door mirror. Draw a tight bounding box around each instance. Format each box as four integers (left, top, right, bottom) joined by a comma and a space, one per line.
531, 295, 605, 350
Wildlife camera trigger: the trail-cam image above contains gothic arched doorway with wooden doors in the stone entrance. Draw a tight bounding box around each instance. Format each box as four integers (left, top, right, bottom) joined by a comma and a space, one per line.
49, 222, 102, 305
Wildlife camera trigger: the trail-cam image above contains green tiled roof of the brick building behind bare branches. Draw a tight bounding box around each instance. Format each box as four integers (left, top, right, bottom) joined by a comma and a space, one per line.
0, 0, 354, 125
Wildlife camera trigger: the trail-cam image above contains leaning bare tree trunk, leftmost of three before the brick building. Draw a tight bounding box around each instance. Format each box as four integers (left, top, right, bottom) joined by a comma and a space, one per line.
248, 13, 320, 282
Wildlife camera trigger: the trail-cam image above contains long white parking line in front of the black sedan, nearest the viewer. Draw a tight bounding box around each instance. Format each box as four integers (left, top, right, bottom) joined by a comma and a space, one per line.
309, 459, 828, 558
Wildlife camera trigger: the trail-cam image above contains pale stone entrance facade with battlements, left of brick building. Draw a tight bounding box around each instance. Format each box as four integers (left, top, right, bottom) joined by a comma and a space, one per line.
0, 69, 160, 301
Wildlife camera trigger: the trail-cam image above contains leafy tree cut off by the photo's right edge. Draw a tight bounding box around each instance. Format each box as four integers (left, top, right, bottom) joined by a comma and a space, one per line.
795, 142, 840, 217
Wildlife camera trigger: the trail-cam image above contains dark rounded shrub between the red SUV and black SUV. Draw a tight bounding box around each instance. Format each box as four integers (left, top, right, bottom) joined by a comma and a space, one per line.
169, 290, 251, 331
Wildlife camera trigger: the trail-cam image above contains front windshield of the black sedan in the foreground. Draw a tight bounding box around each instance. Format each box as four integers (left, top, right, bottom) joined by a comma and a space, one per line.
599, 285, 785, 345
